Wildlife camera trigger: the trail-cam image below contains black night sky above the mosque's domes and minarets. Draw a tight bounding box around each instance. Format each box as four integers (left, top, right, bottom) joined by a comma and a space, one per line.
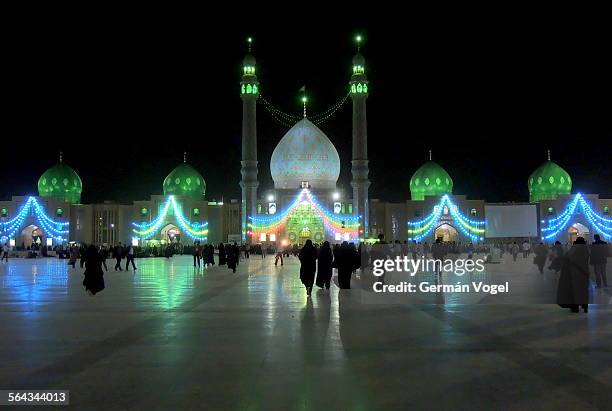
0, 23, 612, 202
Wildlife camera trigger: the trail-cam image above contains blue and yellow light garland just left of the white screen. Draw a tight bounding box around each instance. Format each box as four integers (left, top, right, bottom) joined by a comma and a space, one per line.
408, 194, 485, 241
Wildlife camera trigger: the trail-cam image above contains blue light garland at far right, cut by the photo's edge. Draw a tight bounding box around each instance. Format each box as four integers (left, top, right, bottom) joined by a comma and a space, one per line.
541, 193, 612, 240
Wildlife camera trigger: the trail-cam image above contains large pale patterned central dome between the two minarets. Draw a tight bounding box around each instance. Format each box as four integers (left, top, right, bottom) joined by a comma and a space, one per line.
270, 118, 340, 189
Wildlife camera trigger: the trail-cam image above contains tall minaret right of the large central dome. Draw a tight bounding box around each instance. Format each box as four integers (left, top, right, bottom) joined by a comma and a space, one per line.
349, 36, 370, 238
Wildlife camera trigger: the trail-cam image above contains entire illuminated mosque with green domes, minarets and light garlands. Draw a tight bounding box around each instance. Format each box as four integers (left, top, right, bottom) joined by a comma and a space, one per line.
0, 39, 612, 251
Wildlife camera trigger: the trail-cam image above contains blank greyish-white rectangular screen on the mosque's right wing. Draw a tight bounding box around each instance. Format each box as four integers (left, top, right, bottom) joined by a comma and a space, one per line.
485, 204, 538, 238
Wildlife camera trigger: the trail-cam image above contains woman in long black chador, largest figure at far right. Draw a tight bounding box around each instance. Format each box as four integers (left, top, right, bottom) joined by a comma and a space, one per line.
557, 237, 589, 313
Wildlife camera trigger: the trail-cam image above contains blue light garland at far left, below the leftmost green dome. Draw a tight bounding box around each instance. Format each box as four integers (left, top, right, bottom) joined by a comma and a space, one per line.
0, 196, 70, 241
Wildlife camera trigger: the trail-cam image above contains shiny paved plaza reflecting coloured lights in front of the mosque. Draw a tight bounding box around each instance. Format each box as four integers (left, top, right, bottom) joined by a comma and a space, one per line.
0, 256, 612, 411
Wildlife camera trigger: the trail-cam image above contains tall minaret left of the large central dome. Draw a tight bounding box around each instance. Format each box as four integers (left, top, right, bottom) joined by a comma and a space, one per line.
240, 37, 259, 241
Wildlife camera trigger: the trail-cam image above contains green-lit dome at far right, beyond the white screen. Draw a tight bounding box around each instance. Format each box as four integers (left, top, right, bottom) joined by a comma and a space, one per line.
527, 160, 572, 202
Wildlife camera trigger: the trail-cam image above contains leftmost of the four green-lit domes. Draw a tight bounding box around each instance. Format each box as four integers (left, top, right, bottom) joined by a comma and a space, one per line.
38, 160, 83, 204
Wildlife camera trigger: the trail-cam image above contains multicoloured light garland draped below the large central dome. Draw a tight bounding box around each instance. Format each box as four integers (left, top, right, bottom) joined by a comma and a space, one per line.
247, 188, 361, 238
